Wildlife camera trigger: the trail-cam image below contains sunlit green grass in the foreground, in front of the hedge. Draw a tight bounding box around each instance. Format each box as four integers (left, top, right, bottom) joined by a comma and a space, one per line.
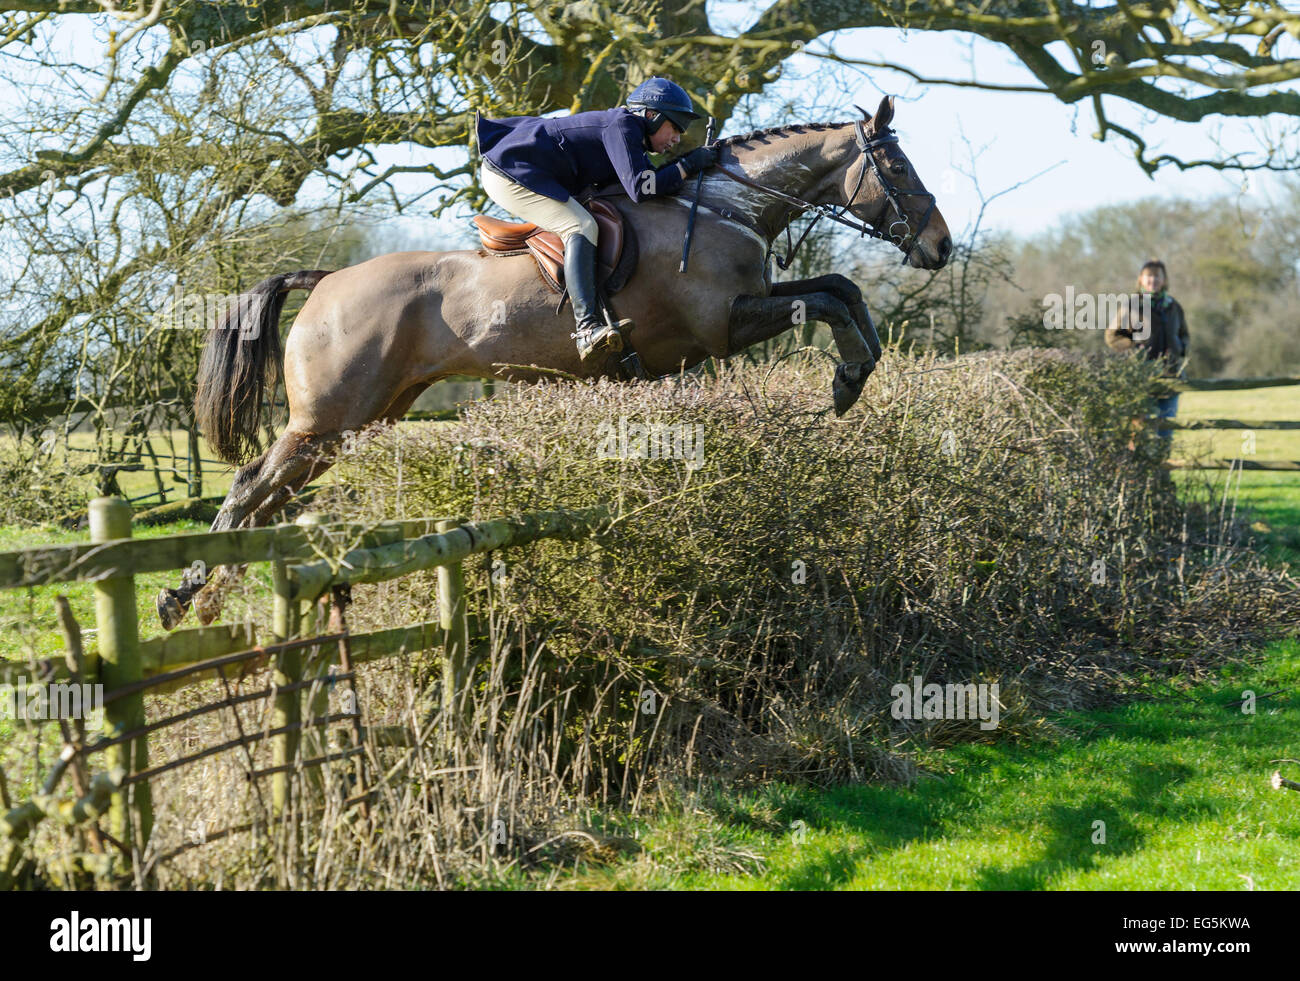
520, 638, 1300, 890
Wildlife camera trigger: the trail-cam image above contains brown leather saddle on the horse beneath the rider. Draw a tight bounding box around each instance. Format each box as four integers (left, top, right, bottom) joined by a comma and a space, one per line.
473, 197, 637, 294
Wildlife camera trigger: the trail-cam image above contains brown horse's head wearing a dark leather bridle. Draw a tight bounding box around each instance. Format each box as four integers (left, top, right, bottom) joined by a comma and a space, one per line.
836, 95, 953, 269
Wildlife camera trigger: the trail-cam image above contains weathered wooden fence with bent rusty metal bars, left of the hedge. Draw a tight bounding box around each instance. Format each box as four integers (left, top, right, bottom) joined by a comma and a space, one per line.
0, 498, 608, 889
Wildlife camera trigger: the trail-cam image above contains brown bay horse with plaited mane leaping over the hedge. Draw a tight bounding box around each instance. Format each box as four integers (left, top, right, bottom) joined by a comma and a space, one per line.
156, 96, 952, 629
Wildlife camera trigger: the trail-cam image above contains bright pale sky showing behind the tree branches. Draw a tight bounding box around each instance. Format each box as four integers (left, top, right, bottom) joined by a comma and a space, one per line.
0, 0, 1294, 248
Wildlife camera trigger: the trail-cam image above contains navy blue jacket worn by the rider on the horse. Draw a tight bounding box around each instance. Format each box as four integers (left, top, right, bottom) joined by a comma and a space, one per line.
475, 105, 683, 201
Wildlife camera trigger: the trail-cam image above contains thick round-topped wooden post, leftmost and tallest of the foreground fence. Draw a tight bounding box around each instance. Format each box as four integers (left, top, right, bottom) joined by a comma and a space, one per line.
90, 498, 153, 847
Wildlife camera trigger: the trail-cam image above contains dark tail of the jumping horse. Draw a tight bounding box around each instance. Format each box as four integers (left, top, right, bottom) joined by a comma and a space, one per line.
194, 269, 333, 464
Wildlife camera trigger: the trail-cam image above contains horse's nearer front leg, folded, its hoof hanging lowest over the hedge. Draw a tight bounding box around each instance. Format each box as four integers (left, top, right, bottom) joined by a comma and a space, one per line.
727, 292, 876, 416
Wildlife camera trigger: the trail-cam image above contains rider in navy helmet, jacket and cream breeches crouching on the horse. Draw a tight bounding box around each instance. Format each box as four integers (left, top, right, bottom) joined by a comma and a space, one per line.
476, 78, 718, 361
